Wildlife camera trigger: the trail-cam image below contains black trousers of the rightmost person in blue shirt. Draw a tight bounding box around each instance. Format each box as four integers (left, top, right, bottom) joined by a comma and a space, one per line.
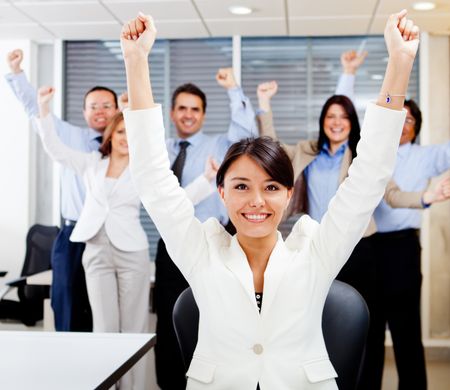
360, 229, 427, 390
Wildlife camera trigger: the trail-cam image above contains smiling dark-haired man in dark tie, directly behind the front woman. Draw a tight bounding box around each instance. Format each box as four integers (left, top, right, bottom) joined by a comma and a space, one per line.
155, 68, 257, 390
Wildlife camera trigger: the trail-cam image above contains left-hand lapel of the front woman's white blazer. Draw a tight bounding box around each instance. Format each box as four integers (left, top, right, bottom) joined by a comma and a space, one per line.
225, 235, 258, 311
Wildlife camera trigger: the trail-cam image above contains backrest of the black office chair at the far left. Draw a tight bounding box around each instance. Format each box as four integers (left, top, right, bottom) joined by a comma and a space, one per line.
18, 224, 59, 312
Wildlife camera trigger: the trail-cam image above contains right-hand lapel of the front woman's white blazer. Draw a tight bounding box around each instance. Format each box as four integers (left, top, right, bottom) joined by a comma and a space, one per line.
261, 232, 294, 315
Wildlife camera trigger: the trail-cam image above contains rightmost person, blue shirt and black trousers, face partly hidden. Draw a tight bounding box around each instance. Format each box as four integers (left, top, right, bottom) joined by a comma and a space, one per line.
370, 100, 450, 390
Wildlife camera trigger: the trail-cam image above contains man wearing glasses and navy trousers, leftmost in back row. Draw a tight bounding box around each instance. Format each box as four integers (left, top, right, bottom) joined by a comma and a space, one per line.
5, 50, 118, 331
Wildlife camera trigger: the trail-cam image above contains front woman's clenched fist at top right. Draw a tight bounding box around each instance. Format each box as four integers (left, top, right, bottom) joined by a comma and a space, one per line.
384, 9, 419, 60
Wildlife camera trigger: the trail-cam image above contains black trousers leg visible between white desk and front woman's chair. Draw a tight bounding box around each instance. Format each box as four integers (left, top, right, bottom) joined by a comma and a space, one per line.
154, 239, 189, 390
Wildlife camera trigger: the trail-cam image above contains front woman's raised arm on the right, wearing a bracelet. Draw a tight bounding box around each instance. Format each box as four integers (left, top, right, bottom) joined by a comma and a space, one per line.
304, 10, 419, 278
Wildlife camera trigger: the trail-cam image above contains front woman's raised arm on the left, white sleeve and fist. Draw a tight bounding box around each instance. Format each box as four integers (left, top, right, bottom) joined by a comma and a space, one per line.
121, 14, 212, 280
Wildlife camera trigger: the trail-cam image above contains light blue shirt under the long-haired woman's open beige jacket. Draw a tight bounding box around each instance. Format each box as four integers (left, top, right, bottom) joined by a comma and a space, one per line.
305, 142, 347, 222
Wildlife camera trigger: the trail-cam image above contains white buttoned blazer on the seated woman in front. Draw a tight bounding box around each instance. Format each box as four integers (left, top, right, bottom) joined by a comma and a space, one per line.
125, 104, 405, 390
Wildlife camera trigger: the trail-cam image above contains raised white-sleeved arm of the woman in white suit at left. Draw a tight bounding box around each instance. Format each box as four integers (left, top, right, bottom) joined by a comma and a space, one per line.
36, 87, 94, 175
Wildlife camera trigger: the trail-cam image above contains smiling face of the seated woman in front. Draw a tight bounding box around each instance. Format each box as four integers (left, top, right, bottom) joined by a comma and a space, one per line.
219, 155, 292, 239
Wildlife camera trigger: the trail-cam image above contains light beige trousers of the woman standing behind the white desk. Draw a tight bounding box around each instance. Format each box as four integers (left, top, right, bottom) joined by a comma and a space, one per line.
83, 228, 150, 390
